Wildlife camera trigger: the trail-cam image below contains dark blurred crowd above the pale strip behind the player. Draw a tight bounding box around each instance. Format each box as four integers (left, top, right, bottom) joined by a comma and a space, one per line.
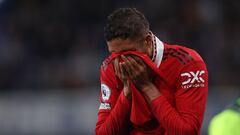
0, 0, 240, 91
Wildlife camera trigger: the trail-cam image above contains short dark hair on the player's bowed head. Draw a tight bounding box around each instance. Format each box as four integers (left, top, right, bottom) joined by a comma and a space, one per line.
104, 8, 149, 41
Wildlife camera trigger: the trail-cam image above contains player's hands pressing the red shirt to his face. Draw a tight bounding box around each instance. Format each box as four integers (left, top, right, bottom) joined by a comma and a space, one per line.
114, 55, 160, 102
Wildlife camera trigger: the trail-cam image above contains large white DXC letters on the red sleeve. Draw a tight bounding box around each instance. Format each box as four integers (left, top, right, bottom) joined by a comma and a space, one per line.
181, 70, 205, 85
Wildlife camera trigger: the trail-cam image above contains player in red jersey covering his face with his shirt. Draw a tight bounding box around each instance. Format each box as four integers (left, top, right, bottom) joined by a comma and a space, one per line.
96, 8, 208, 135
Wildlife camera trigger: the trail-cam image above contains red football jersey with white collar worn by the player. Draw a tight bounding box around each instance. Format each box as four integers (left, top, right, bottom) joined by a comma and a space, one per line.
96, 37, 208, 135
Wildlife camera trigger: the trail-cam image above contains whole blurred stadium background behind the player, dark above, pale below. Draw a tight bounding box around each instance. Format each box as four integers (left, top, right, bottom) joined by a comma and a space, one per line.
0, 0, 240, 135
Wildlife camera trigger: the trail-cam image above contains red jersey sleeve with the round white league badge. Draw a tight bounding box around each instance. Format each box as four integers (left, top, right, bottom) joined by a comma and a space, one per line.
95, 65, 130, 135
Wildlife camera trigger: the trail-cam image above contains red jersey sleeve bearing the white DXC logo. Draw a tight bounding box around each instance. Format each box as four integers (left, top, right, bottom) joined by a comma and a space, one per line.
151, 61, 208, 135
